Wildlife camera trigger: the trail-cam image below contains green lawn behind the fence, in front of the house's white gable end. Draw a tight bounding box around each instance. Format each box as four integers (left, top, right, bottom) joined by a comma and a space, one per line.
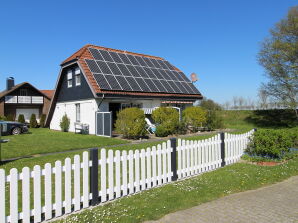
2, 128, 128, 159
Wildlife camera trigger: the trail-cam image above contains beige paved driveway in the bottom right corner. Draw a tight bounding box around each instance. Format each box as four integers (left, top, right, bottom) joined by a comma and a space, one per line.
146, 176, 298, 223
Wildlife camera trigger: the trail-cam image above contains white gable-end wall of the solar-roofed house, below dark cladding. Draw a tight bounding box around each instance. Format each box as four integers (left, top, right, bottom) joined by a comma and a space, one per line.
50, 99, 97, 134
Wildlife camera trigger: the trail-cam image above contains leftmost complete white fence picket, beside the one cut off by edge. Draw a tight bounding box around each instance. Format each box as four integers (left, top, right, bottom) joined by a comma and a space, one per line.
10, 168, 18, 223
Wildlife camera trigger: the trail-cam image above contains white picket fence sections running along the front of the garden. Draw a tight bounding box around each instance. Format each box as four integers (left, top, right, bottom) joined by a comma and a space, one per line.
0, 130, 253, 223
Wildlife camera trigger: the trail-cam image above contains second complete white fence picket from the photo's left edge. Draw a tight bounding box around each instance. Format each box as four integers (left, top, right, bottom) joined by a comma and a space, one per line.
21, 167, 31, 223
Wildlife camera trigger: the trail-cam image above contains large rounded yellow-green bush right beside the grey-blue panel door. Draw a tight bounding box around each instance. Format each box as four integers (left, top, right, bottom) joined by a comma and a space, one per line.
115, 108, 146, 139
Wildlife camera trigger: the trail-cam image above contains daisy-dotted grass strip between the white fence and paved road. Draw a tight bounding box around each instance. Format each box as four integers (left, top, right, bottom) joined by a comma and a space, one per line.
55, 158, 298, 223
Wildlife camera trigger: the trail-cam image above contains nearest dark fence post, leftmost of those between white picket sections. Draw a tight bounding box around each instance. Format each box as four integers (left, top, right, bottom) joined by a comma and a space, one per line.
90, 148, 98, 206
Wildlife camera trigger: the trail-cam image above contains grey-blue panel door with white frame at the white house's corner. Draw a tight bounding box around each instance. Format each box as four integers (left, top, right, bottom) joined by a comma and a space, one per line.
95, 112, 112, 137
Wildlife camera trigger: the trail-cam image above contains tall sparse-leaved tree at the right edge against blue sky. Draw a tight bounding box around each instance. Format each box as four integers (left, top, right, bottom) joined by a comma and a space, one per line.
258, 6, 298, 119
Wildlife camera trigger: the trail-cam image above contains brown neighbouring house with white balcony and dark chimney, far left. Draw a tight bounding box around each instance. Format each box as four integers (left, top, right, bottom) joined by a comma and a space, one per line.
0, 77, 54, 122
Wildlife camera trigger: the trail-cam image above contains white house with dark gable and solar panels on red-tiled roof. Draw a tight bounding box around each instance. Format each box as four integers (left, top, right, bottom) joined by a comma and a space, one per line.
46, 45, 202, 136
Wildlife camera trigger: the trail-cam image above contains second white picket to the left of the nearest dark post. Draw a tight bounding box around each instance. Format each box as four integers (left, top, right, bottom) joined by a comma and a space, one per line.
74, 155, 81, 211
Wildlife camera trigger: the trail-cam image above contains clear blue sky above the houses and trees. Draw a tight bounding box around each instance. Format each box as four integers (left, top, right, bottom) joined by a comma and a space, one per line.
0, 0, 297, 103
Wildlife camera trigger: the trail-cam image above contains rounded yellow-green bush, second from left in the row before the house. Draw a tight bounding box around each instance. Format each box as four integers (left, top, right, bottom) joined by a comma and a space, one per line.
152, 107, 179, 136
